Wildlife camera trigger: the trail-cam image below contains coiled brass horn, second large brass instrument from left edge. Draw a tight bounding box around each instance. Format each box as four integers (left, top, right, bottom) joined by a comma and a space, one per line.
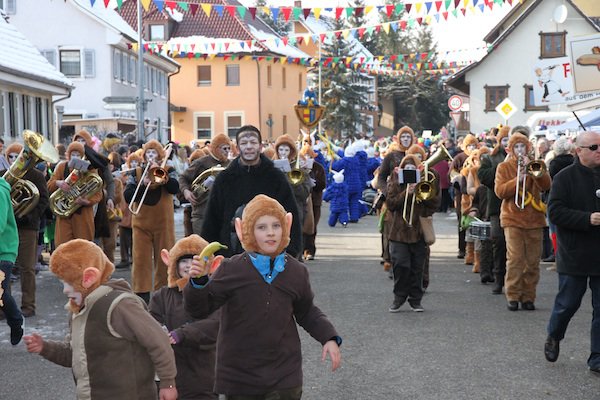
50, 157, 104, 218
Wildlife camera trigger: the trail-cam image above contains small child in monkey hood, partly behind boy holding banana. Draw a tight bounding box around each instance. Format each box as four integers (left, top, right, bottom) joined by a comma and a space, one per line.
149, 235, 223, 400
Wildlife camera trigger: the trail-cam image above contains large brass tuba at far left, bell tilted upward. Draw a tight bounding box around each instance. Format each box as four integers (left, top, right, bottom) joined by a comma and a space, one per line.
3, 130, 58, 218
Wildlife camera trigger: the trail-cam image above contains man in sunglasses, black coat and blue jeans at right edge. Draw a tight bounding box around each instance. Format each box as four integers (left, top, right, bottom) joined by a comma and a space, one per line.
544, 132, 600, 373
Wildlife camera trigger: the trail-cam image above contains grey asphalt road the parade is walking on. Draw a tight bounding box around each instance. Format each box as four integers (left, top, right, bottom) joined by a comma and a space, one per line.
0, 206, 600, 400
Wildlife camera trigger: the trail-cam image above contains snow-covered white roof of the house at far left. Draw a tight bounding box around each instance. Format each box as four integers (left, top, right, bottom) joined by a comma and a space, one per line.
0, 14, 73, 89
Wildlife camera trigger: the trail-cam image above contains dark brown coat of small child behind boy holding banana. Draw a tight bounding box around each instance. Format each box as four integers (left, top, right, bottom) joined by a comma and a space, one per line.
149, 286, 221, 400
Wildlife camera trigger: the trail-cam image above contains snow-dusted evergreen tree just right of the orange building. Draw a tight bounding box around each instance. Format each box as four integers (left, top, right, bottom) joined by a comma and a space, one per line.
322, 20, 369, 138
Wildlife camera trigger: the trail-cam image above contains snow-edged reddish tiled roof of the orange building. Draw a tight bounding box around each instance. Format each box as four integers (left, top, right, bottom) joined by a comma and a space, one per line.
120, 0, 308, 57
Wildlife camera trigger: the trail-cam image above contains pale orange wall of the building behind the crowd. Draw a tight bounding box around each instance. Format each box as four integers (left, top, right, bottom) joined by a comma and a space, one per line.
171, 57, 306, 143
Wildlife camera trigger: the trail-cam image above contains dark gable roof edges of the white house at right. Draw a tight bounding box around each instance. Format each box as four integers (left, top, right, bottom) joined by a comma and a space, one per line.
447, 0, 600, 94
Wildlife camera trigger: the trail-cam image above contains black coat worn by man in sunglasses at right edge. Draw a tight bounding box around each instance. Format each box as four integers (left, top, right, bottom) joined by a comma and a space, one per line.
548, 159, 600, 276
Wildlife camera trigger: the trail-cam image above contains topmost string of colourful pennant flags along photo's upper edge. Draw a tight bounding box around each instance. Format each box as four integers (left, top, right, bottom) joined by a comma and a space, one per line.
103, 0, 523, 22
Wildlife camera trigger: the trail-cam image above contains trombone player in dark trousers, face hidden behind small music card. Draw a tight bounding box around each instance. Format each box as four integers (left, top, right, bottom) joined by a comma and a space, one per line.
386, 154, 440, 313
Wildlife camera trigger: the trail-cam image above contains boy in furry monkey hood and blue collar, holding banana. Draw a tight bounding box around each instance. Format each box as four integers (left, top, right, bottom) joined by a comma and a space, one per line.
183, 194, 342, 400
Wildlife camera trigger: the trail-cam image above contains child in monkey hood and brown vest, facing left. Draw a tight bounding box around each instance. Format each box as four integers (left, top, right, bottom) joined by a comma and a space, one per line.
24, 239, 177, 400
